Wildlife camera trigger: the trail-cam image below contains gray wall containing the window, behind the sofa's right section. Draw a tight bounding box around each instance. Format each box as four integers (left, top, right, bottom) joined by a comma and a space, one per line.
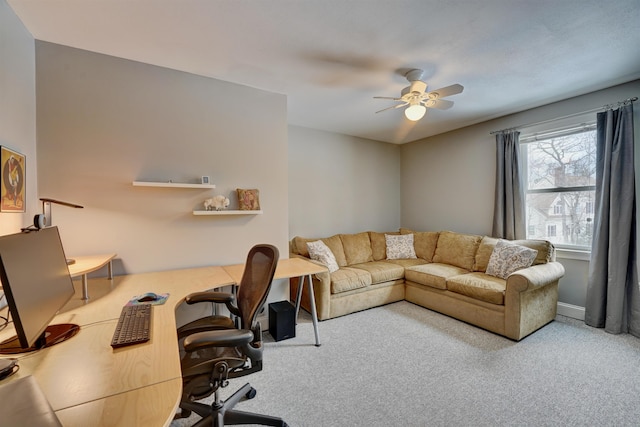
401, 80, 640, 316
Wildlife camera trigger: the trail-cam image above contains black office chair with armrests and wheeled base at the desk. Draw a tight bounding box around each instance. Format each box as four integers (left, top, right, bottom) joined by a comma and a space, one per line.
177, 245, 287, 427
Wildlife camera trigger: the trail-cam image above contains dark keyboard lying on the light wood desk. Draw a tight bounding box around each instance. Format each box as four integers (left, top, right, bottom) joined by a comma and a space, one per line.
111, 304, 153, 348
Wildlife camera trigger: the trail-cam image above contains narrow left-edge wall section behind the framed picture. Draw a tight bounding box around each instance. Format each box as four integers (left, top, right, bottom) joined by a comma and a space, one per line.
0, 0, 40, 235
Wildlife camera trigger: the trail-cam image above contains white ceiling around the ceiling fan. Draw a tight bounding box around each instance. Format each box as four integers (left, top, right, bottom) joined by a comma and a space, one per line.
7, 0, 640, 143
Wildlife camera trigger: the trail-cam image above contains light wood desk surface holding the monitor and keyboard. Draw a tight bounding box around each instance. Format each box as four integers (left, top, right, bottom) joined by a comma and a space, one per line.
0, 267, 233, 427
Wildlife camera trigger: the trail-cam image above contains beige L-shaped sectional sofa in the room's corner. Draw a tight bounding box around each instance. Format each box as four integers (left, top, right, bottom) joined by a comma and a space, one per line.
290, 229, 564, 341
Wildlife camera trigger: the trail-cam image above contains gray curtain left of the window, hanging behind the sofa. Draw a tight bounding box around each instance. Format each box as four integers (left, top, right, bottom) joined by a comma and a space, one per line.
491, 131, 526, 240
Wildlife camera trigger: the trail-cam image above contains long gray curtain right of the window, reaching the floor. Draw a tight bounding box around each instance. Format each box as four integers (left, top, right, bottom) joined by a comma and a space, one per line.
585, 104, 640, 337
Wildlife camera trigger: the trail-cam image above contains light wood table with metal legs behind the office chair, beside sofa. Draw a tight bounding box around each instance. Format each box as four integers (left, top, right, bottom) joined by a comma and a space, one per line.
223, 258, 327, 346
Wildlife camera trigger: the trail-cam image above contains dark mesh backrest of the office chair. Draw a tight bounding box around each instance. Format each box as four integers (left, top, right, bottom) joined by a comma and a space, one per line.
238, 244, 280, 330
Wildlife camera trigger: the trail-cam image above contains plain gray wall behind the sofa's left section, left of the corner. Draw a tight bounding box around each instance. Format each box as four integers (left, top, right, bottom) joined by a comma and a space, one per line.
289, 126, 400, 238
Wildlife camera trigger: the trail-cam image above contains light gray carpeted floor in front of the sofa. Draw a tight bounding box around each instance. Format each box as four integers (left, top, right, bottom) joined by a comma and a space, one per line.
172, 301, 640, 427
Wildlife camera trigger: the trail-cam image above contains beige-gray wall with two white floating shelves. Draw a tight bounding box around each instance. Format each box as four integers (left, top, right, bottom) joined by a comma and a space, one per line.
36, 42, 289, 280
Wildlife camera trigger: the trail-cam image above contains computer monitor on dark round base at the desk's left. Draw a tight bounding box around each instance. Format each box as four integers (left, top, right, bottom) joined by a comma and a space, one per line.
0, 227, 80, 354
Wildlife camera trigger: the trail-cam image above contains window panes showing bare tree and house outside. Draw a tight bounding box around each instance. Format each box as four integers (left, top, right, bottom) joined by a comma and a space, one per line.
522, 130, 596, 249
